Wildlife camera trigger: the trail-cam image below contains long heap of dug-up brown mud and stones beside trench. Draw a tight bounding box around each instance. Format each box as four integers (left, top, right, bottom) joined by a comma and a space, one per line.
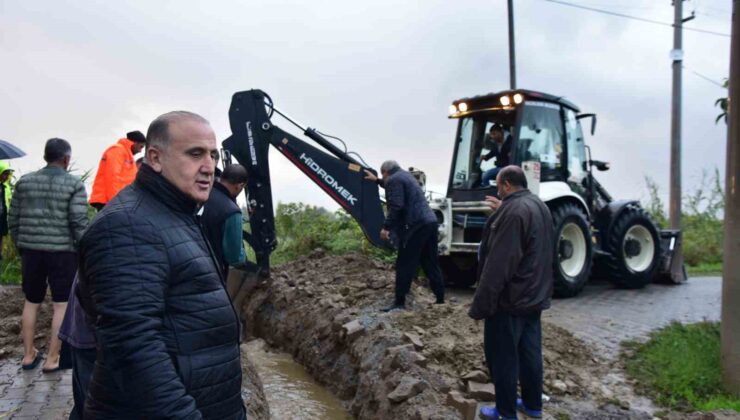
241, 251, 651, 419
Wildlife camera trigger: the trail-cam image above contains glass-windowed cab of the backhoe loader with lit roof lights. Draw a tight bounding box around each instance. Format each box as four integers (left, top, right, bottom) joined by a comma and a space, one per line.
447, 90, 593, 201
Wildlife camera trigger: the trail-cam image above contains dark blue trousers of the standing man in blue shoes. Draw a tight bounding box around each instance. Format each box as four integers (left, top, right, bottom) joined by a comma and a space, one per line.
483, 311, 542, 418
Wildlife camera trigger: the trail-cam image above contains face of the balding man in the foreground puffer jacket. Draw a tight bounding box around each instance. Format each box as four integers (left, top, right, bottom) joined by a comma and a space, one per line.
147, 119, 218, 203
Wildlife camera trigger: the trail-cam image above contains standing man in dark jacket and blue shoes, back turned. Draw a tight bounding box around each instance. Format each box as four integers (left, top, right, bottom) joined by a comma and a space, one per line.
468, 166, 554, 419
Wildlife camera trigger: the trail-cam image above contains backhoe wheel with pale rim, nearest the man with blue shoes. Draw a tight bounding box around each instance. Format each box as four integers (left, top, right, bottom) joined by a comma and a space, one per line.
551, 203, 593, 297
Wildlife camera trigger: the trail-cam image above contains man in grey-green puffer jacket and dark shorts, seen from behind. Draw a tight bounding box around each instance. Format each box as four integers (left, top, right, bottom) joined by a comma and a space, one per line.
8, 138, 87, 373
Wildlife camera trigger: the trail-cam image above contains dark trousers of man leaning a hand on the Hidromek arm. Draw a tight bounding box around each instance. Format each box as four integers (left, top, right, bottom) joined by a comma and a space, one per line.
396, 223, 445, 305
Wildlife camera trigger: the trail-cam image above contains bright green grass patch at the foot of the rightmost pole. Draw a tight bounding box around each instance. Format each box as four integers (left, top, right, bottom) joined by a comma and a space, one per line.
625, 322, 740, 411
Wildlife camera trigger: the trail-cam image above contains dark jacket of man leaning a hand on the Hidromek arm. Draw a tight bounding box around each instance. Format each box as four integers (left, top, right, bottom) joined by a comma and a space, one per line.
380, 168, 437, 240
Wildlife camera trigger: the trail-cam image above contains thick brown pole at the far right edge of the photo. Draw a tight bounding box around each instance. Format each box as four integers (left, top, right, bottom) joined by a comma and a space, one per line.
721, 0, 740, 396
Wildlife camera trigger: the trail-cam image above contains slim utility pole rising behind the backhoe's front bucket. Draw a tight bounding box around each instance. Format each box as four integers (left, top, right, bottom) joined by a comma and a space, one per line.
668, 0, 684, 229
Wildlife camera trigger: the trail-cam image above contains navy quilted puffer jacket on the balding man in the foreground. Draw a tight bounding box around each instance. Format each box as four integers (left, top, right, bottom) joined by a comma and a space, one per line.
78, 165, 244, 420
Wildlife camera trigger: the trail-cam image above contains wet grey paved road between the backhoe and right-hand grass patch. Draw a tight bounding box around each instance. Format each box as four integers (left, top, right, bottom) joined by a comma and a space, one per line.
543, 277, 722, 357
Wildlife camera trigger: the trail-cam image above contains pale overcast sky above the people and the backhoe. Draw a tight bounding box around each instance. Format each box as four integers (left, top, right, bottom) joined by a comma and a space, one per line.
0, 0, 731, 208
